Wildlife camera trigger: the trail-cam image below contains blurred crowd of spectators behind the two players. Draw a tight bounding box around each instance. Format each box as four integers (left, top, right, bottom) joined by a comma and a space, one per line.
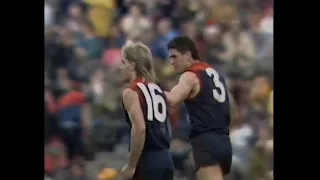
44, 0, 273, 180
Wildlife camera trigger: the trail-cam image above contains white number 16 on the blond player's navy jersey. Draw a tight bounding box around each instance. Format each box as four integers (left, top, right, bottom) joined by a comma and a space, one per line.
137, 83, 167, 123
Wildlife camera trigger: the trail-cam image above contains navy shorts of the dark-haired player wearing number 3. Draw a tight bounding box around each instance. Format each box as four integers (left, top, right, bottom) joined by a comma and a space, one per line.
191, 132, 232, 175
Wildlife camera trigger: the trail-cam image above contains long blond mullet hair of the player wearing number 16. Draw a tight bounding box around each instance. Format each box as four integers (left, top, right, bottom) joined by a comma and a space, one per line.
122, 41, 156, 81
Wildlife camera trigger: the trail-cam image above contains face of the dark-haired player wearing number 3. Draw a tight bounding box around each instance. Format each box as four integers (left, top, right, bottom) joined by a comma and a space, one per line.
169, 49, 189, 73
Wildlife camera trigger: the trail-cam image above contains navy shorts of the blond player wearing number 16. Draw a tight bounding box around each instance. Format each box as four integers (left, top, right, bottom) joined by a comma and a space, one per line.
132, 150, 174, 180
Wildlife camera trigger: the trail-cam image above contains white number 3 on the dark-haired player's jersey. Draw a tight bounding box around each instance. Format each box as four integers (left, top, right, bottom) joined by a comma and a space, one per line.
206, 68, 226, 103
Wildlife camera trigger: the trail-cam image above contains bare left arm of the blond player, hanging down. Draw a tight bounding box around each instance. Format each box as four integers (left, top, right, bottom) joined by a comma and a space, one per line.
123, 88, 146, 168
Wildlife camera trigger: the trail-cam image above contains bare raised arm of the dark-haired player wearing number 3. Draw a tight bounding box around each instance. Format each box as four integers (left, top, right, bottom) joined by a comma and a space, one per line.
165, 72, 199, 106
